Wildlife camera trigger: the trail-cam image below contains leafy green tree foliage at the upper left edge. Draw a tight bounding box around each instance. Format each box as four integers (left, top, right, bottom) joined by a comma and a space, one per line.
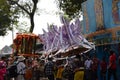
0, 0, 17, 36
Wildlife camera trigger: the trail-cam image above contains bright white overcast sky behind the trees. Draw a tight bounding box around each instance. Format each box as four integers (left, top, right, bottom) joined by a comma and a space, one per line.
0, 0, 61, 49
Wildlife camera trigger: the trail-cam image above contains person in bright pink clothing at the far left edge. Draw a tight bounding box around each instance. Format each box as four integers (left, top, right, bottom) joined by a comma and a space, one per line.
0, 59, 6, 80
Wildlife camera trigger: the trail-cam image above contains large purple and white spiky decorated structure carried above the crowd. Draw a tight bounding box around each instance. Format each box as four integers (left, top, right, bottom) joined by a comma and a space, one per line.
39, 16, 95, 58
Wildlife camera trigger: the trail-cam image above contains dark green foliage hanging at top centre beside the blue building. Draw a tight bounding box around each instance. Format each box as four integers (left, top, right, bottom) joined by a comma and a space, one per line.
57, 0, 86, 18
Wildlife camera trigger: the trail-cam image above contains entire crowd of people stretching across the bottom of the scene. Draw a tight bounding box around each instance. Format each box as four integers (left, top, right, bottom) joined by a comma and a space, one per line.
0, 50, 119, 80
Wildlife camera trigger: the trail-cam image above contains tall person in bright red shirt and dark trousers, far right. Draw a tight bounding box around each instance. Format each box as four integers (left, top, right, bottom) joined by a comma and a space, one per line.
108, 50, 117, 80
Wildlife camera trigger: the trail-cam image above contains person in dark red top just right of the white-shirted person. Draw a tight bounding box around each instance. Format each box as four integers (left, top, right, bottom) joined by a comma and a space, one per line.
91, 54, 99, 80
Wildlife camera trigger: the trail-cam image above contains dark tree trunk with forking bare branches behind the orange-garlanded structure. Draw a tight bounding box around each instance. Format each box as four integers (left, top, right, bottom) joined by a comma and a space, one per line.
8, 0, 38, 33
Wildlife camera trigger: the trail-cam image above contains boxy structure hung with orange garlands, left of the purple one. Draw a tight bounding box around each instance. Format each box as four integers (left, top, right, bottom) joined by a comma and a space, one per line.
13, 34, 38, 54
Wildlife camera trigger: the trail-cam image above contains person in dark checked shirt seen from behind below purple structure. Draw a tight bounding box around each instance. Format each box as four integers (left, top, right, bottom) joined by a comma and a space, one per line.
44, 57, 55, 80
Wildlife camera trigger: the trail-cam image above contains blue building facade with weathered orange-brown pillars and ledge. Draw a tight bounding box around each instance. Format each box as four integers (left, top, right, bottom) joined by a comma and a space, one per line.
81, 0, 120, 79
